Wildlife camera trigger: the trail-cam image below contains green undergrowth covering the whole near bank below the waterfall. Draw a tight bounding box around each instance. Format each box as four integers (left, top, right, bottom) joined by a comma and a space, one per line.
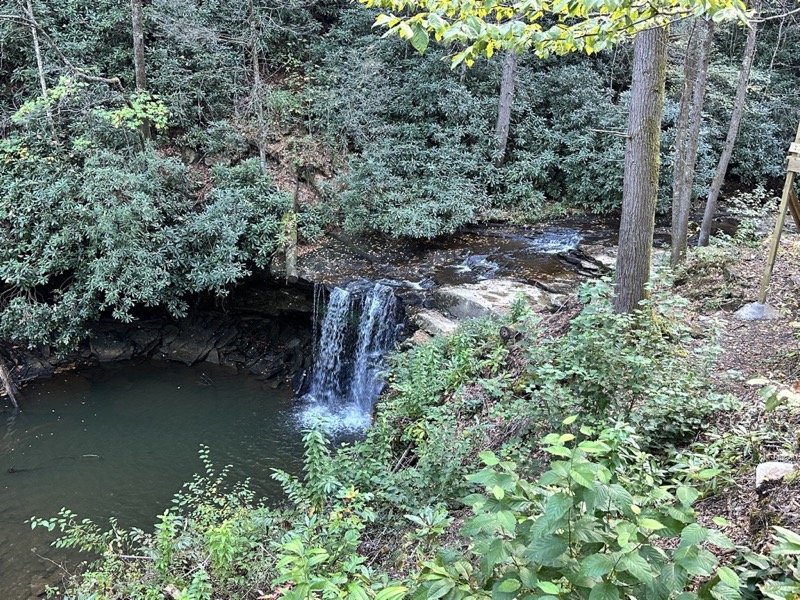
32, 283, 796, 600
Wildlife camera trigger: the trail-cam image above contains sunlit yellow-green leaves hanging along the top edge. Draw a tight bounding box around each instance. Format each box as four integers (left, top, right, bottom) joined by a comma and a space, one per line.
360, 0, 745, 66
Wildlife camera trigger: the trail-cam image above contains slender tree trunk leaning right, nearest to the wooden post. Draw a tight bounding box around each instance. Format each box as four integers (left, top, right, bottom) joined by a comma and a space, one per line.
697, 0, 761, 246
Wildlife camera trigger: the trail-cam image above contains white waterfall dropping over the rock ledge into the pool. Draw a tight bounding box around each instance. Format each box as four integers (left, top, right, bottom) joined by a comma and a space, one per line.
301, 283, 399, 431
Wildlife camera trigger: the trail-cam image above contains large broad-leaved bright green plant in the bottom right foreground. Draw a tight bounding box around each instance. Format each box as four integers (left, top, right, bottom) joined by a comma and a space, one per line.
417, 419, 736, 600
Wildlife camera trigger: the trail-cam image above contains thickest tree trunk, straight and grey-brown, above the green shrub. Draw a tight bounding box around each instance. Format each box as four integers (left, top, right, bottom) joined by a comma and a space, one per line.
614, 27, 669, 312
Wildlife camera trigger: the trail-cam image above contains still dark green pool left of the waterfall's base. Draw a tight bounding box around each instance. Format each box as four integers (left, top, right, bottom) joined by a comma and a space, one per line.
0, 362, 302, 600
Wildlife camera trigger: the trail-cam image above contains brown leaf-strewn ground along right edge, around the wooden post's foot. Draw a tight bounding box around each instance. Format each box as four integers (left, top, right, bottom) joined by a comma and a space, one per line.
678, 234, 800, 550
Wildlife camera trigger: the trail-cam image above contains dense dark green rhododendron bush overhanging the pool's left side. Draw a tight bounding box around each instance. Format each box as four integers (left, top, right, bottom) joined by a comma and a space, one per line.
0, 80, 291, 349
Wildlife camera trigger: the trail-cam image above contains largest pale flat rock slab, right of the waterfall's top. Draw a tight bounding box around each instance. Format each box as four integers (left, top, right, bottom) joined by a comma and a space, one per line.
433, 279, 563, 320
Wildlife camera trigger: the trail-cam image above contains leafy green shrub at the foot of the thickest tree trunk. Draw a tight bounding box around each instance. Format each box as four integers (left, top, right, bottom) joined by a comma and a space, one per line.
527, 284, 733, 447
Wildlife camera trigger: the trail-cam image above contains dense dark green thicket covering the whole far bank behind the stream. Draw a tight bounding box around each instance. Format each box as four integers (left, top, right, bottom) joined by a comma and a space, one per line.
0, 0, 800, 347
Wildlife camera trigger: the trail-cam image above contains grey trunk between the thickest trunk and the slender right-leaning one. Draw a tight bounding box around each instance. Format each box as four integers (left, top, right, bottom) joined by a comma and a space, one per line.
670, 19, 714, 267
